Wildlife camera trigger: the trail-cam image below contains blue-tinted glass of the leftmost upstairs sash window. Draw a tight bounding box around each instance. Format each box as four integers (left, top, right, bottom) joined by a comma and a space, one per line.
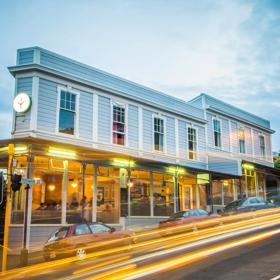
59, 91, 76, 135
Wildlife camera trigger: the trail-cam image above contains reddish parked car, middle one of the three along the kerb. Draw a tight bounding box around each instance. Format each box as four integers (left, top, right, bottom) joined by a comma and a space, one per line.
159, 209, 220, 231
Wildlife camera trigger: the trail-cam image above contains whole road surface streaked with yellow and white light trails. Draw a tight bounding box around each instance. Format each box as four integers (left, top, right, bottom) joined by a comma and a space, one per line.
1, 210, 280, 280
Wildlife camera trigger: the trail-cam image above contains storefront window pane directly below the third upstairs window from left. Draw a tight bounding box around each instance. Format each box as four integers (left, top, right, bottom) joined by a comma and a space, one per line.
153, 173, 174, 216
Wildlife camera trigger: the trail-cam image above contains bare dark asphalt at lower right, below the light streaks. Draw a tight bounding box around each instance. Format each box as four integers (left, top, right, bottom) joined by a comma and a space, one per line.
141, 230, 280, 280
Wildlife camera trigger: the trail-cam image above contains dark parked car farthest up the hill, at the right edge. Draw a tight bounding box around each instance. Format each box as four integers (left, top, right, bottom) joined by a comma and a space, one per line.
221, 197, 276, 215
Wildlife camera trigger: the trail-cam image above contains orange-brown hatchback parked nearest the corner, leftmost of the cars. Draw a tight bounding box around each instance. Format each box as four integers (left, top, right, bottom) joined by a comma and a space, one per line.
43, 223, 135, 260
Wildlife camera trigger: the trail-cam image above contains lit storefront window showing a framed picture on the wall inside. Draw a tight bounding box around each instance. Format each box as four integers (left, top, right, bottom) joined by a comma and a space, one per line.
97, 167, 120, 224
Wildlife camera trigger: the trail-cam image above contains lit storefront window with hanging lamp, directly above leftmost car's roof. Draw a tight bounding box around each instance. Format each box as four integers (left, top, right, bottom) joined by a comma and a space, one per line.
66, 161, 93, 224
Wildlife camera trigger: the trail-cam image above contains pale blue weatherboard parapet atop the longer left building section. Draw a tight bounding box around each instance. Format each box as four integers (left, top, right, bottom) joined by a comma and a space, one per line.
8, 47, 206, 123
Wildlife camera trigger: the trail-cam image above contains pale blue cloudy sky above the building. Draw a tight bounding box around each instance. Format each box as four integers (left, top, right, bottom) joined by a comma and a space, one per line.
0, 0, 280, 150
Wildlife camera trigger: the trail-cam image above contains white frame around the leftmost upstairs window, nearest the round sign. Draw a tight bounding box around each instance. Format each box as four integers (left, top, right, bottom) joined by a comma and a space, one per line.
55, 86, 80, 138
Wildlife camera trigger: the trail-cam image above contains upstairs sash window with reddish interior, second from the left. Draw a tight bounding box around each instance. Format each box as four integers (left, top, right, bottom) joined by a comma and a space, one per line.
113, 104, 125, 145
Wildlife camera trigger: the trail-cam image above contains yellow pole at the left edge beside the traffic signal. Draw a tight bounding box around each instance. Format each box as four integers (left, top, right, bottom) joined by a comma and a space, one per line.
2, 144, 15, 272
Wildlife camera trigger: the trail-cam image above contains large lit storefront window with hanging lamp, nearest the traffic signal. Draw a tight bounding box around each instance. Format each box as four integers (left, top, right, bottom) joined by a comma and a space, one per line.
31, 157, 64, 224
